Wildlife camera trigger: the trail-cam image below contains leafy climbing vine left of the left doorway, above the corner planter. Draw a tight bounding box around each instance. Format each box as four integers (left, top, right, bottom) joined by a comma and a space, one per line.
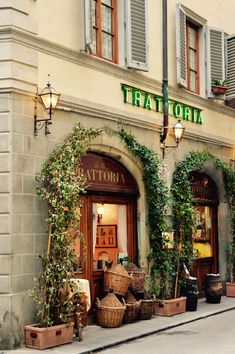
30, 125, 101, 326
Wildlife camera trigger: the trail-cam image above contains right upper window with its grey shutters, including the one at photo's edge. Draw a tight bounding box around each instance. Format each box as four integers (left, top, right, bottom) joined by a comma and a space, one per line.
176, 5, 235, 108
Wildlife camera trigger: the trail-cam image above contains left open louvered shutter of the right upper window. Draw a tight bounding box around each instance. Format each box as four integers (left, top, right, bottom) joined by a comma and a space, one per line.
176, 5, 187, 87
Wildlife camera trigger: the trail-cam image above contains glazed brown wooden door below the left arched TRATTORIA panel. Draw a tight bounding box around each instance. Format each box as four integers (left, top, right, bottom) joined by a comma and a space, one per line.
81, 195, 137, 315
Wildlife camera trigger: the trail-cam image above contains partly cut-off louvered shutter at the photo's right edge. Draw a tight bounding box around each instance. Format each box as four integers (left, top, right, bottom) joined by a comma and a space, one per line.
225, 35, 235, 103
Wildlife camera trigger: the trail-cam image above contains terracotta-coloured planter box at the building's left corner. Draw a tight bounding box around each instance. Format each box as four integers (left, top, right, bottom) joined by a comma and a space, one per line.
24, 322, 74, 349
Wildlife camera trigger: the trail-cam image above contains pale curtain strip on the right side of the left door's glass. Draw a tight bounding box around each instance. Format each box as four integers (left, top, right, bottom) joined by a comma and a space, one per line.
117, 205, 127, 253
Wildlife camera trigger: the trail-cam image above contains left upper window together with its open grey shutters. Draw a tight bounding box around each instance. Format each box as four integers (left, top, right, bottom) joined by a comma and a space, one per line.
84, 0, 148, 71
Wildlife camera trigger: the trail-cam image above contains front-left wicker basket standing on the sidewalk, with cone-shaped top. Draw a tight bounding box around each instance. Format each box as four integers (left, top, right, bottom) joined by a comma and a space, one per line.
96, 293, 126, 328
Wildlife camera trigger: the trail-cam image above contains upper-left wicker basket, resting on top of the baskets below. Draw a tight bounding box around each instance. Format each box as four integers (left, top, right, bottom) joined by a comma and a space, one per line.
104, 264, 132, 296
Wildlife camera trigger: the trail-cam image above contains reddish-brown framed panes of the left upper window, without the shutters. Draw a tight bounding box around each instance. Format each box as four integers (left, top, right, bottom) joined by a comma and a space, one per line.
91, 0, 117, 62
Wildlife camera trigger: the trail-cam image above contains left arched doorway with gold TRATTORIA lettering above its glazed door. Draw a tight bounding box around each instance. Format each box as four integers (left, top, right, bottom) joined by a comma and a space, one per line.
72, 152, 138, 320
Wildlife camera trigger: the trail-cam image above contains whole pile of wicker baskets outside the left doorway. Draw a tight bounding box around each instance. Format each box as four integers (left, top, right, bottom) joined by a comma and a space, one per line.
96, 263, 153, 328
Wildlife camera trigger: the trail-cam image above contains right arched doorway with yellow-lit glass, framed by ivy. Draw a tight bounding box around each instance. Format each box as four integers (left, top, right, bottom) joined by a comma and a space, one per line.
189, 172, 219, 297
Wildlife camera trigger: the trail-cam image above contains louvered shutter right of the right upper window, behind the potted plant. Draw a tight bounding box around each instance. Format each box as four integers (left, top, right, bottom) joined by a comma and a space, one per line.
206, 27, 225, 98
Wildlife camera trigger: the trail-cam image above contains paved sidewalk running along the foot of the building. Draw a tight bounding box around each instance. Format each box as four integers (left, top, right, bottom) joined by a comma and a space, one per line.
5, 296, 235, 354
